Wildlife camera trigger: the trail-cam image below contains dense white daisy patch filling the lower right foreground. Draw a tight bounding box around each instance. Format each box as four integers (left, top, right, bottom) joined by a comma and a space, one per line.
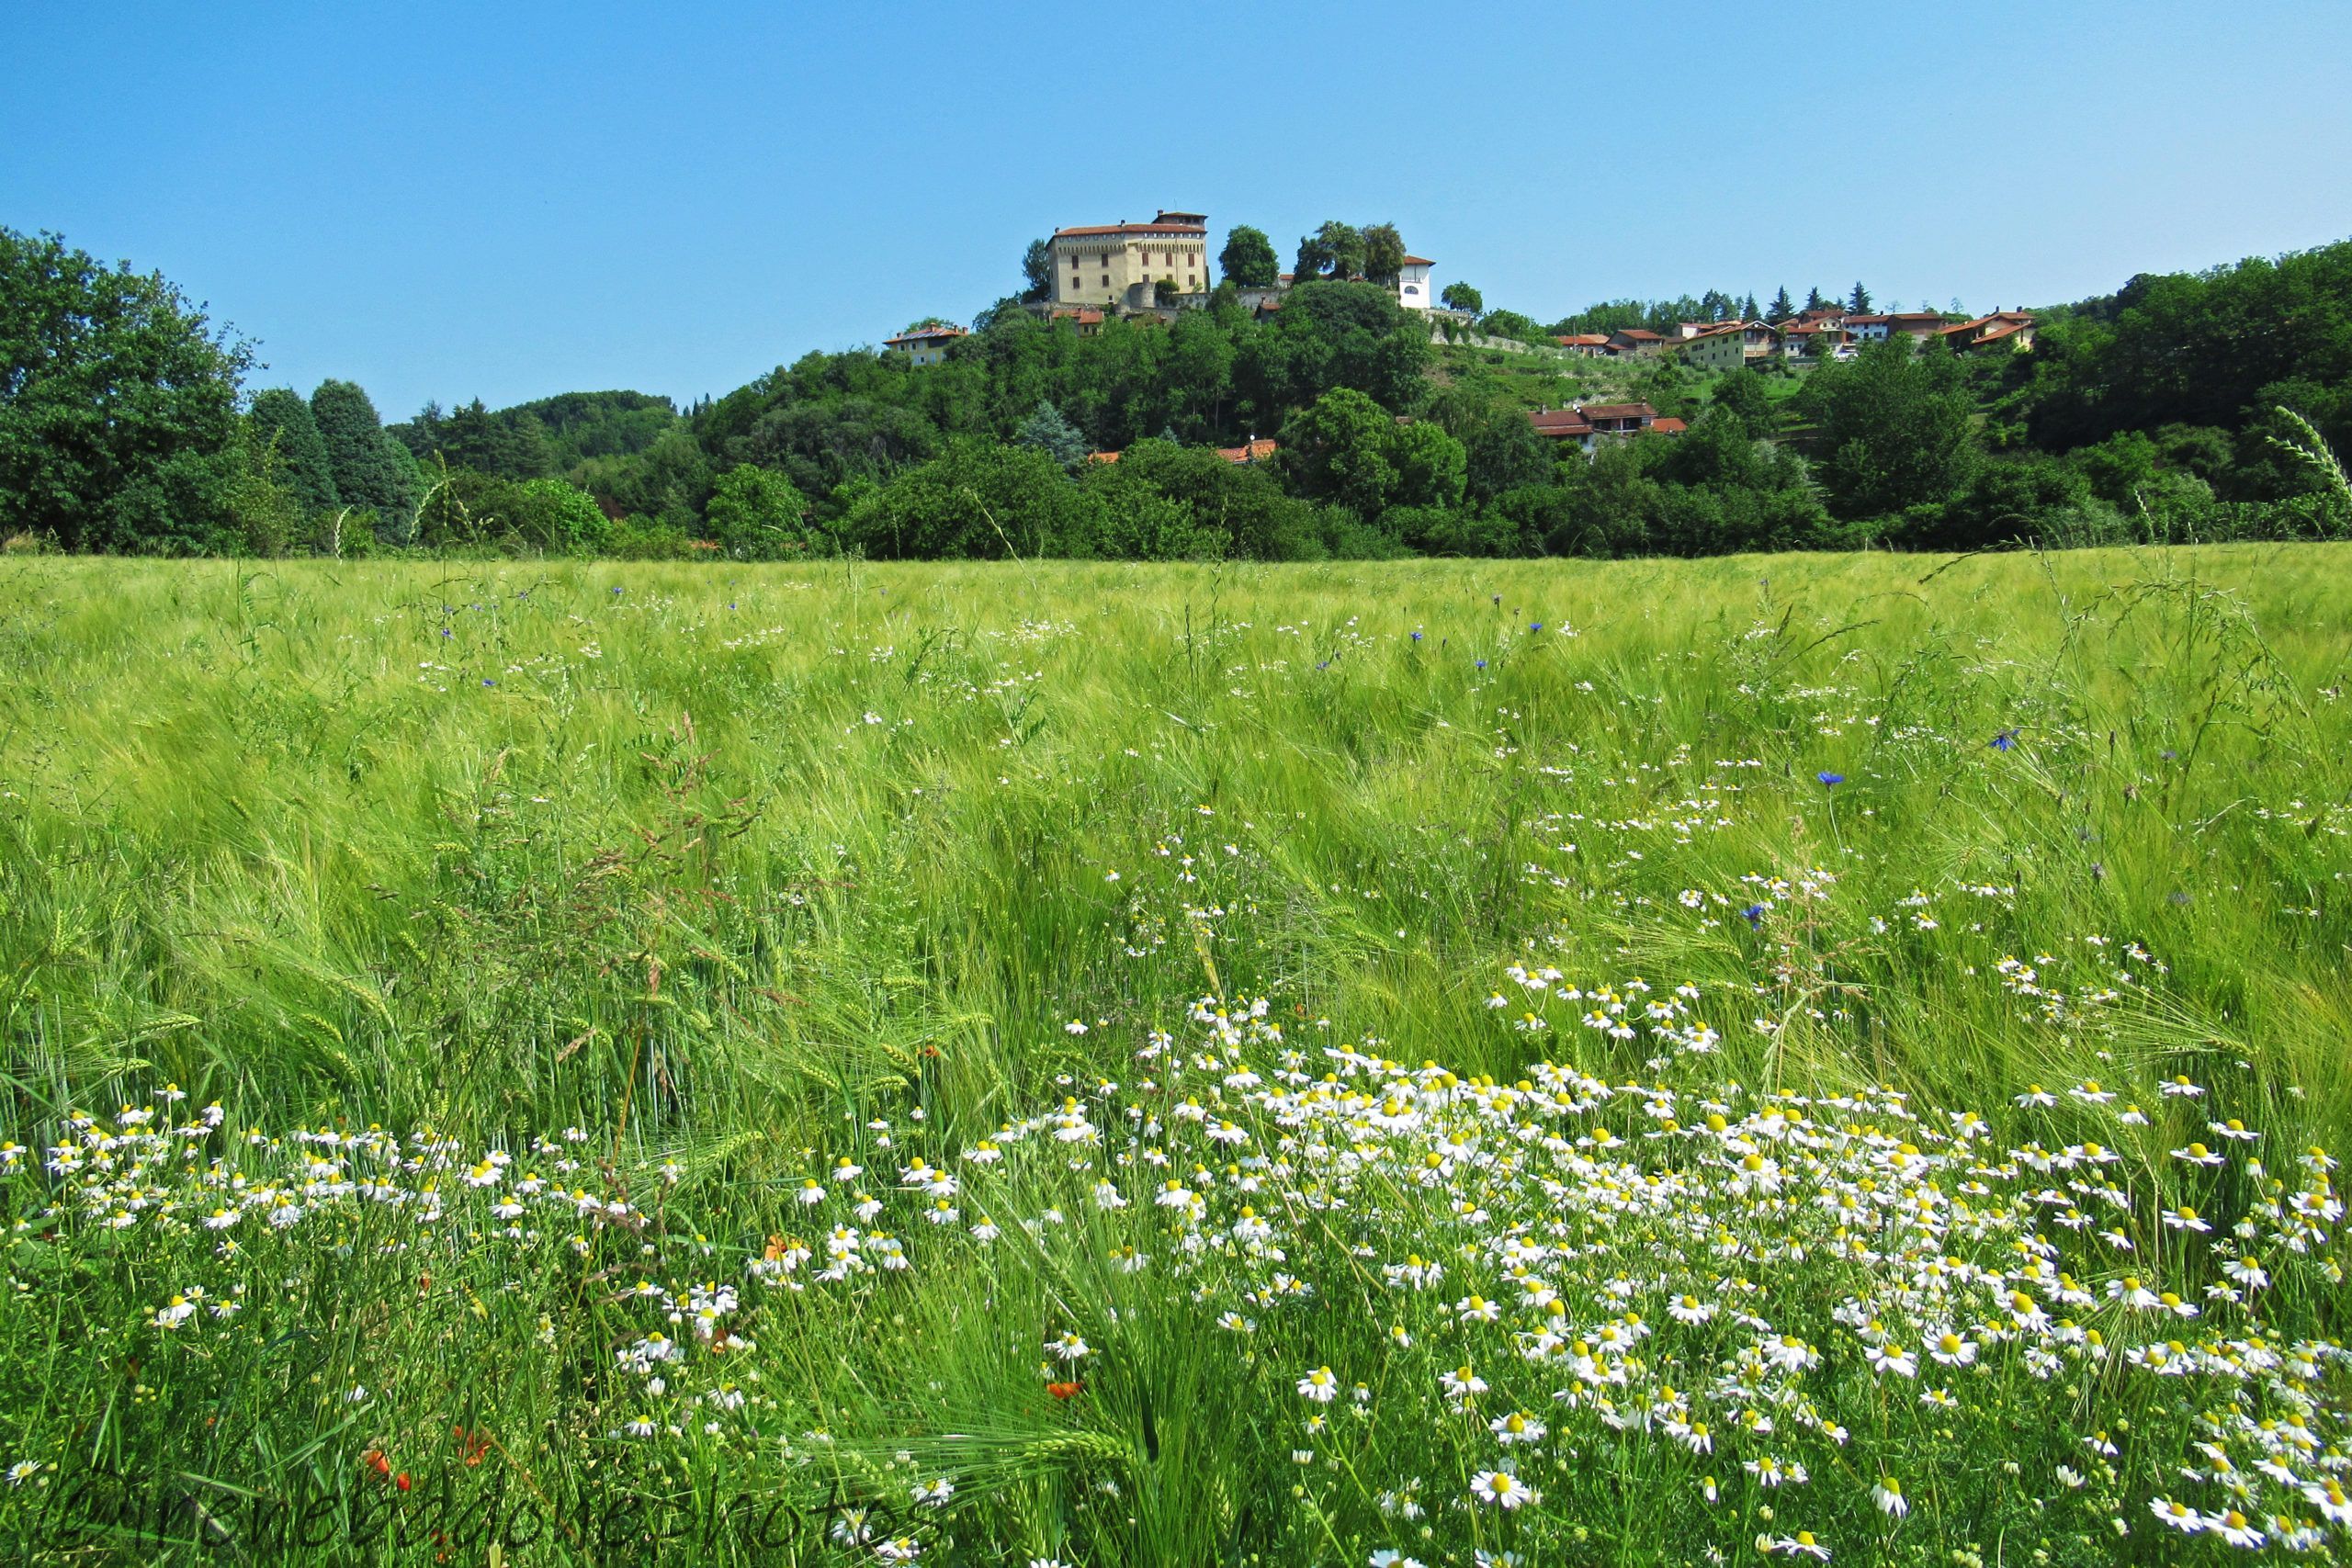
757, 982, 2352, 1556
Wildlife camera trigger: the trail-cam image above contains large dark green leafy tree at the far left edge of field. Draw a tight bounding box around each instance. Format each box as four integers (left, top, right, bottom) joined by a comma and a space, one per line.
0, 228, 252, 555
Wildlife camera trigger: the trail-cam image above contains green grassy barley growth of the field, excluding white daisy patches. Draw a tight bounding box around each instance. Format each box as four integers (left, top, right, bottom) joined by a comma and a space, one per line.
0, 546, 2352, 1563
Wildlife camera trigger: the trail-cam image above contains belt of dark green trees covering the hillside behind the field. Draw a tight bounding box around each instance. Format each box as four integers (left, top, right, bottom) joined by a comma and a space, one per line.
0, 223, 2352, 559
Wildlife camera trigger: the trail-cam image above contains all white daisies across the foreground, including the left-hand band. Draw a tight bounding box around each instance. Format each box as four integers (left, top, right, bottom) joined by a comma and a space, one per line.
0, 964, 2352, 1561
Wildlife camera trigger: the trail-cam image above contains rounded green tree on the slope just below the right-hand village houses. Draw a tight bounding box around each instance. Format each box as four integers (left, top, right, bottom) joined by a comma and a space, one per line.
1797, 339, 1975, 520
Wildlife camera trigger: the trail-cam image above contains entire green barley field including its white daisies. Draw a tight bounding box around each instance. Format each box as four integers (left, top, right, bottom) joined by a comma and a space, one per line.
0, 546, 2352, 1568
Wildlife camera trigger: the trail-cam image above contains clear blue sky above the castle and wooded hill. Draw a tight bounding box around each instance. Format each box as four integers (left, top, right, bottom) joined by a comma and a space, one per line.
0, 0, 2352, 419
